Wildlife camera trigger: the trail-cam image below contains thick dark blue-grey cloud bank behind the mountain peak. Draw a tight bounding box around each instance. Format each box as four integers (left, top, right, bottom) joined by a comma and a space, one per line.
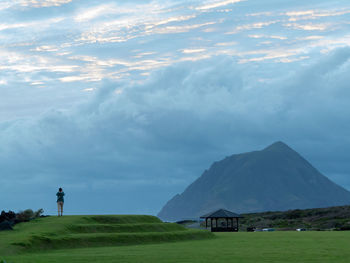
0, 48, 350, 217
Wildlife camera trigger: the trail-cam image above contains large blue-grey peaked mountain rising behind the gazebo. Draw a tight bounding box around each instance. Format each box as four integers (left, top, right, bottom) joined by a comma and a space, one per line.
158, 142, 350, 221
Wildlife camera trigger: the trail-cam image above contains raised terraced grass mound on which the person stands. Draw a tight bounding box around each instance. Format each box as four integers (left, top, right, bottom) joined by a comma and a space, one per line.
0, 215, 212, 256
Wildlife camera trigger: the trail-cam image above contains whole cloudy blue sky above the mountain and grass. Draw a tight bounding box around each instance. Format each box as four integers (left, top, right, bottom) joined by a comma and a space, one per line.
0, 0, 350, 214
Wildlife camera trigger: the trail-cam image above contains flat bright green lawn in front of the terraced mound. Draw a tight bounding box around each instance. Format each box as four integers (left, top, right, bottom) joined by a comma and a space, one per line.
6, 231, 350, 263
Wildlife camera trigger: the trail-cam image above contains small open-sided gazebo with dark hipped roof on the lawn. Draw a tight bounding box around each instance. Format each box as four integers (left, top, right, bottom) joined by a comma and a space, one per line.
200, 209, 242, 232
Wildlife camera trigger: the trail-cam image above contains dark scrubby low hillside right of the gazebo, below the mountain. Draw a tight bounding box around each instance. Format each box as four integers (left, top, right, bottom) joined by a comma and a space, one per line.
240, 206, 350, 230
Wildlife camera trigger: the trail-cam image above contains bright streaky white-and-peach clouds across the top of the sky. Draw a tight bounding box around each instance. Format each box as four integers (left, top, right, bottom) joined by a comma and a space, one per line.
0, 0, 349, 100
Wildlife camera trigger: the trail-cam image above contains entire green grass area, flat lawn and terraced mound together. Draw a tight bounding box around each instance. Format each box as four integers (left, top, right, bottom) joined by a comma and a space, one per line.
0, 216, 350, 263
